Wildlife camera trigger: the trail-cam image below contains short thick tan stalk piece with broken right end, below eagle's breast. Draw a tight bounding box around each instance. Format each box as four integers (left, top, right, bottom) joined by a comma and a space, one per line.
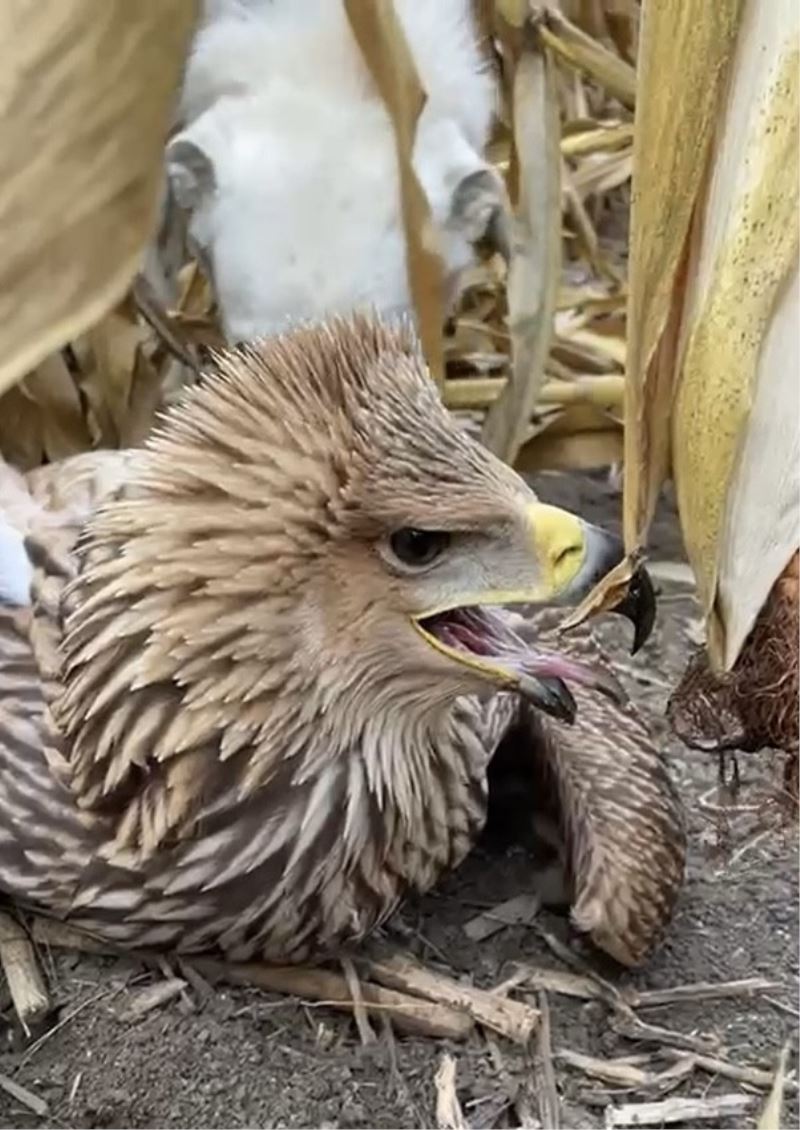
367, 954, 539, 1044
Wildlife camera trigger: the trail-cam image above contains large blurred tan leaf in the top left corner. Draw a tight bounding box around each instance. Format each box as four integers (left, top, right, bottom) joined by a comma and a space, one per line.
0, 0, 197, 390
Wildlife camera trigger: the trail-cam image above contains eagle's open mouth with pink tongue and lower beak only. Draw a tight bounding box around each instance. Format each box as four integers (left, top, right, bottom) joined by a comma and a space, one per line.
415, 605, 619, 722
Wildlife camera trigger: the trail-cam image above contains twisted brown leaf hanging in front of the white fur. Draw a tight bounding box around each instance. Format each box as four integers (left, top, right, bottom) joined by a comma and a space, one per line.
345, 0, 444, 384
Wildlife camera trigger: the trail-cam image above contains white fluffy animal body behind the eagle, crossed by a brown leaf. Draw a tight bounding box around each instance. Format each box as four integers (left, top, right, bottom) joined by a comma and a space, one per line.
167, 0, 502, 340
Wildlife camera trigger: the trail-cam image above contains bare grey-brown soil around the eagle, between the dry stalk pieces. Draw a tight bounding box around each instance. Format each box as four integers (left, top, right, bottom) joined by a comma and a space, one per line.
0, 476, 799, 1128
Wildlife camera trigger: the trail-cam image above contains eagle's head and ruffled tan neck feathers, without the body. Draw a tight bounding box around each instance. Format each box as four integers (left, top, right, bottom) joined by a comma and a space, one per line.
56, 315, 652, 845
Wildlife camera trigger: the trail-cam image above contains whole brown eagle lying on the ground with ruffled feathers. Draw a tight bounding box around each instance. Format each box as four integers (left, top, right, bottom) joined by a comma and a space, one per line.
0, 314, 685, 964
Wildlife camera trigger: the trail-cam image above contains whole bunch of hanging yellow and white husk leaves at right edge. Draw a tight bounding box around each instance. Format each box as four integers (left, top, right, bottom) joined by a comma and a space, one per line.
625, 0, 800, 669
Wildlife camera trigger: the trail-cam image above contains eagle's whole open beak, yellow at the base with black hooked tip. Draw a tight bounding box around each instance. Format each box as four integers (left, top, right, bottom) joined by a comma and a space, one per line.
414, 503, 655, 722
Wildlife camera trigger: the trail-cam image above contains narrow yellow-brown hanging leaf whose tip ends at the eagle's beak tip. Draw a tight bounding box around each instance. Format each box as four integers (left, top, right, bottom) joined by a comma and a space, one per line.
624, 0, 741, 549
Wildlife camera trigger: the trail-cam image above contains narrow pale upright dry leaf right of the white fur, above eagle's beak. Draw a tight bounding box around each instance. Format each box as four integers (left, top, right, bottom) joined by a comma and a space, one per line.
482, 20, 560, 462
